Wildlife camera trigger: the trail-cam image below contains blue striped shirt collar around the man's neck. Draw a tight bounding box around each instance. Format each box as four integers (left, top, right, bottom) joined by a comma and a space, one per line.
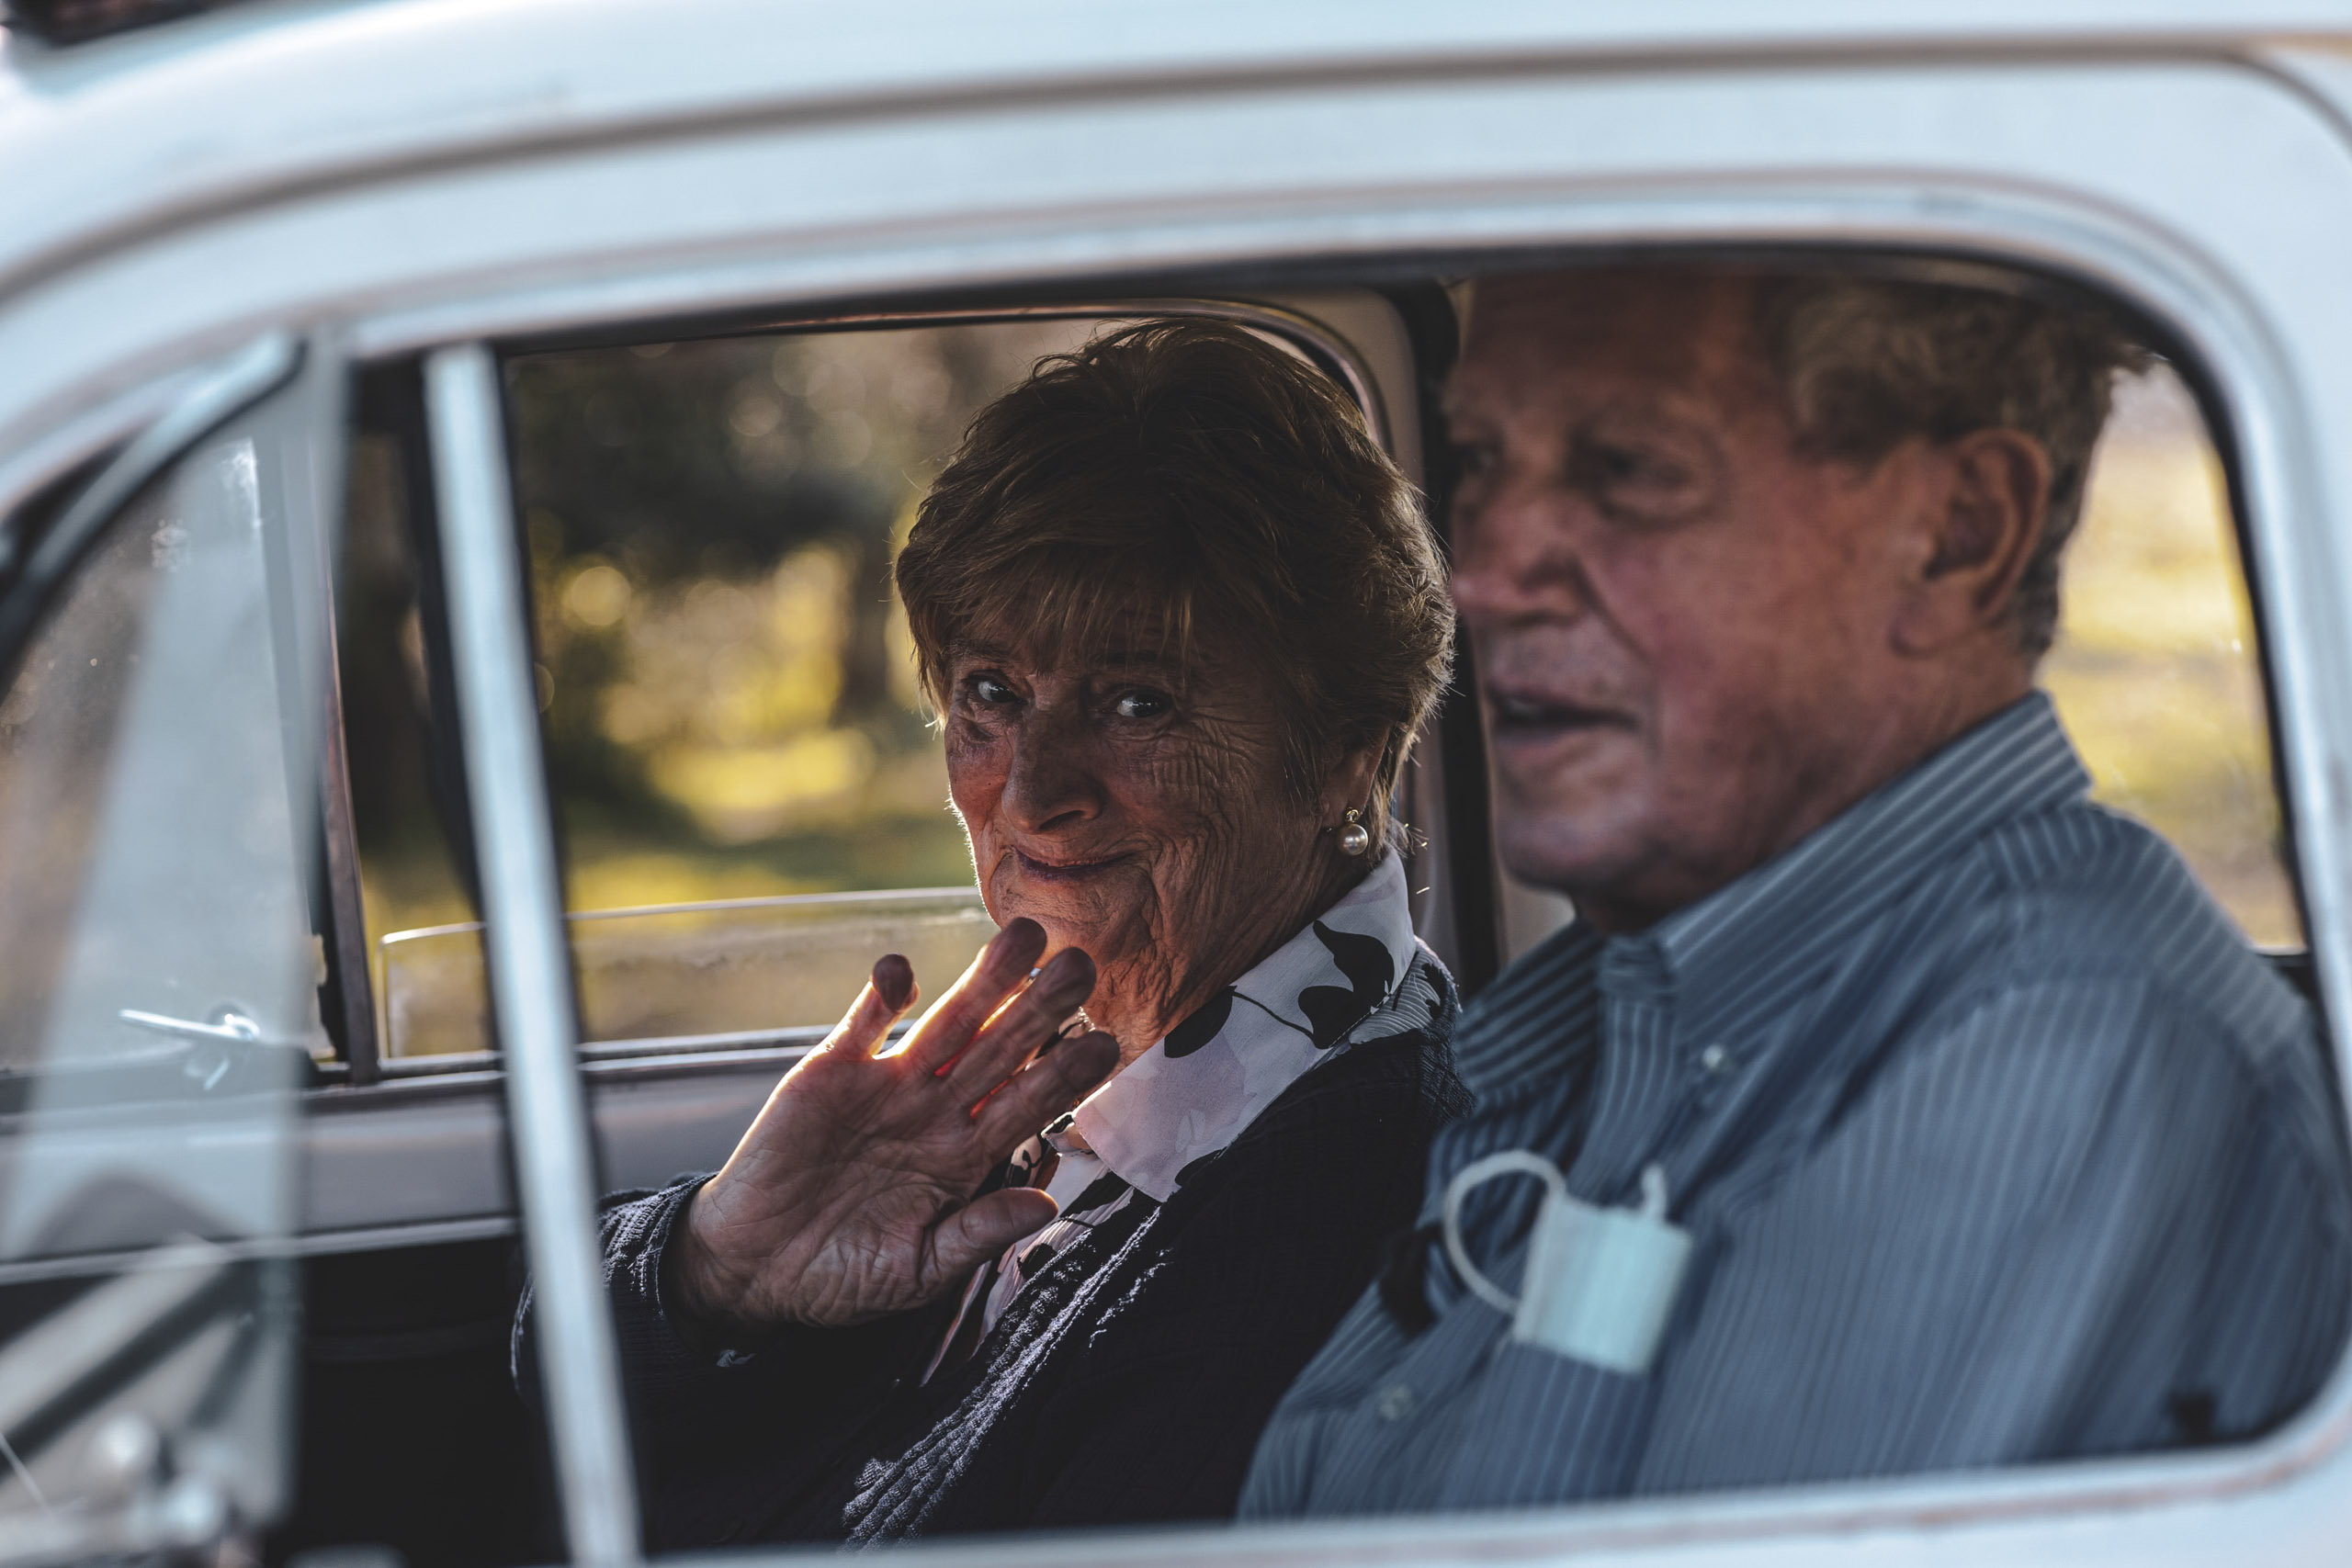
1453, 691, 2091, 1100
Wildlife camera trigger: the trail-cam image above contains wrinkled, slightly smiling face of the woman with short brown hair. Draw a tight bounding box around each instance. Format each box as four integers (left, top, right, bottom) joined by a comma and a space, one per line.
945, 637, 1371, 1060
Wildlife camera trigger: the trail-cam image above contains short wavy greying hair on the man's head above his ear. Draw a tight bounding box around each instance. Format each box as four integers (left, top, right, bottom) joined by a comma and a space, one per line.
1755, 275, 2147, 659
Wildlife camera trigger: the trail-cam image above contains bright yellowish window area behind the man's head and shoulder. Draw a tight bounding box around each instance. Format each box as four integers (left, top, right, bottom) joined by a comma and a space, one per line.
1500, 362, 2302, 957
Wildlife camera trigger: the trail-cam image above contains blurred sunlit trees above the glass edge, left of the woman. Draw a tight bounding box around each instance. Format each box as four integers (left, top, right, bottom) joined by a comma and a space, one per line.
345, 320, 1101, 959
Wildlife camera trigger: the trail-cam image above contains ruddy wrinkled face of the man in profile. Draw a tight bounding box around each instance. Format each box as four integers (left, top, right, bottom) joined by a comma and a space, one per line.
1449, 273, 1922, 929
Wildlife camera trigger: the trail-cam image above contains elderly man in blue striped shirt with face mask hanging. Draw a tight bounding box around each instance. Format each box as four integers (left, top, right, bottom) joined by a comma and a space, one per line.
1244, 270, 2352, 1517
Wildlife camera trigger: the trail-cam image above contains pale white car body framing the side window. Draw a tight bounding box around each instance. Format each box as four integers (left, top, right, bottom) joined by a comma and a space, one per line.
14, 0, 2352, 1568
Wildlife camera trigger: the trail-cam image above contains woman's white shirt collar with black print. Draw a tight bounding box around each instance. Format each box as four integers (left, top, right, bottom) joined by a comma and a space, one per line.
1075, 853, 1416, 1201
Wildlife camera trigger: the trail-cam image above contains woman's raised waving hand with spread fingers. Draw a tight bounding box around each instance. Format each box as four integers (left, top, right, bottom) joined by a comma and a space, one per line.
665, 919, 1120, 1345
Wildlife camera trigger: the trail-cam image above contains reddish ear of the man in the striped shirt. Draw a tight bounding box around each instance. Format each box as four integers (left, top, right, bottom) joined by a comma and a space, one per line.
1894, 430, 2051, 653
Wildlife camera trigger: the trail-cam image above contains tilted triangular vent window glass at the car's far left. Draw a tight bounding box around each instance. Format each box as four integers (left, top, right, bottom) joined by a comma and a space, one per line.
0, 359, 329, 1554
